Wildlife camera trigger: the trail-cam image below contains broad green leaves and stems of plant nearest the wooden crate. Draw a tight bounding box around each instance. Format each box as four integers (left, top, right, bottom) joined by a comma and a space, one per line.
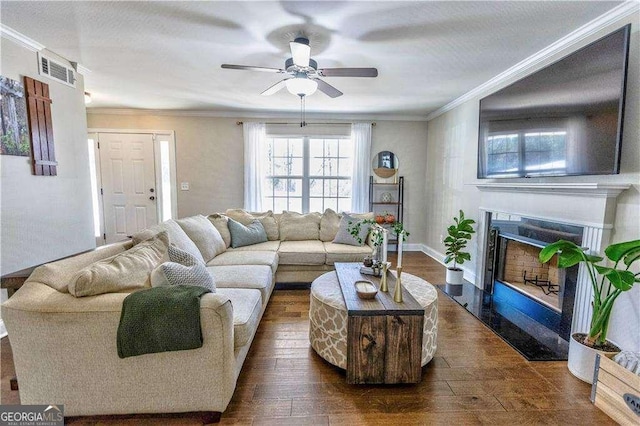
539, 240, 640, 349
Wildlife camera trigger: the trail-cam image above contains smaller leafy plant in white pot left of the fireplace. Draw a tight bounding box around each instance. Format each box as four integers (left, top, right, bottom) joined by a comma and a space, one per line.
443, 210, 476, 284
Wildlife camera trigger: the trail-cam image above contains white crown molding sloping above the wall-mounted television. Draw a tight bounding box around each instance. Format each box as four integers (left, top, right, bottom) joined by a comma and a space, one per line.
427, 0, 640, 121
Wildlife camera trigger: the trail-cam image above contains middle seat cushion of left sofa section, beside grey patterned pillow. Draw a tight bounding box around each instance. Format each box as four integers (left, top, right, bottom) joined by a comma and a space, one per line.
207, 265, 273, 305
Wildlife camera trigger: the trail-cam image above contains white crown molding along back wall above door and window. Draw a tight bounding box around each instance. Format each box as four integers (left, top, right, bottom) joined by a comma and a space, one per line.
87, 108, 427, 124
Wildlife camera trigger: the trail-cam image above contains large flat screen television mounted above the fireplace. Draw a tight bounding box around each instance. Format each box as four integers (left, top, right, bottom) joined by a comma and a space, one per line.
478, 25, 631, 179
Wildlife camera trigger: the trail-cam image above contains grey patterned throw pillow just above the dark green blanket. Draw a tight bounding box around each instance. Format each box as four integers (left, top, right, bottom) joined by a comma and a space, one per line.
151, 246, 216, 292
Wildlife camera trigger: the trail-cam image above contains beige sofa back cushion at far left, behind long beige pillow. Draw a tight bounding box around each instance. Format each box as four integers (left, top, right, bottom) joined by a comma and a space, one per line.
27, 241, 132, 293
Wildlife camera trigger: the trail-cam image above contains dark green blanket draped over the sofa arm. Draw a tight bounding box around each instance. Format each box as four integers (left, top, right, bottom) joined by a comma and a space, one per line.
118, 285, 210, 358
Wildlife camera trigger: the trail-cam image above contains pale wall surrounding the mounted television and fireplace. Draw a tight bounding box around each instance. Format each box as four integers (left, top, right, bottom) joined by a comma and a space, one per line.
425, 14, 640, 351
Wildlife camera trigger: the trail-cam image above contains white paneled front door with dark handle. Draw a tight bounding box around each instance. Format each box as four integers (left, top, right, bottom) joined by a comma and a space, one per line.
98, 133, 158, 244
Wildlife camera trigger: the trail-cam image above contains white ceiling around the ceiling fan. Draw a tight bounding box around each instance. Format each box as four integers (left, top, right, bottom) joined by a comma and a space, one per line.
0, 0, 621, 116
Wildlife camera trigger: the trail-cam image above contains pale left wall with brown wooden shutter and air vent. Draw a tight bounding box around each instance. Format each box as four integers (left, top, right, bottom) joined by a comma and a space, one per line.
0, 38, 95, 275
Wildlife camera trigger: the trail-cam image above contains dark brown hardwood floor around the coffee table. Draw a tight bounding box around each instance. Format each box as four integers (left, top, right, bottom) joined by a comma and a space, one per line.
1, 253, 615, 426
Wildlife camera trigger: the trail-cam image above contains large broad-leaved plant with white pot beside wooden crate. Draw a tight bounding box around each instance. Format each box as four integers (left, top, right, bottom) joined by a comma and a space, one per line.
539, 240, 640, 383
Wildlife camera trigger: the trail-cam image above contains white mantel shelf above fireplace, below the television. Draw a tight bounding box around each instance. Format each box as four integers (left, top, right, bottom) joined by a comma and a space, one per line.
475, 182, 631, 198
